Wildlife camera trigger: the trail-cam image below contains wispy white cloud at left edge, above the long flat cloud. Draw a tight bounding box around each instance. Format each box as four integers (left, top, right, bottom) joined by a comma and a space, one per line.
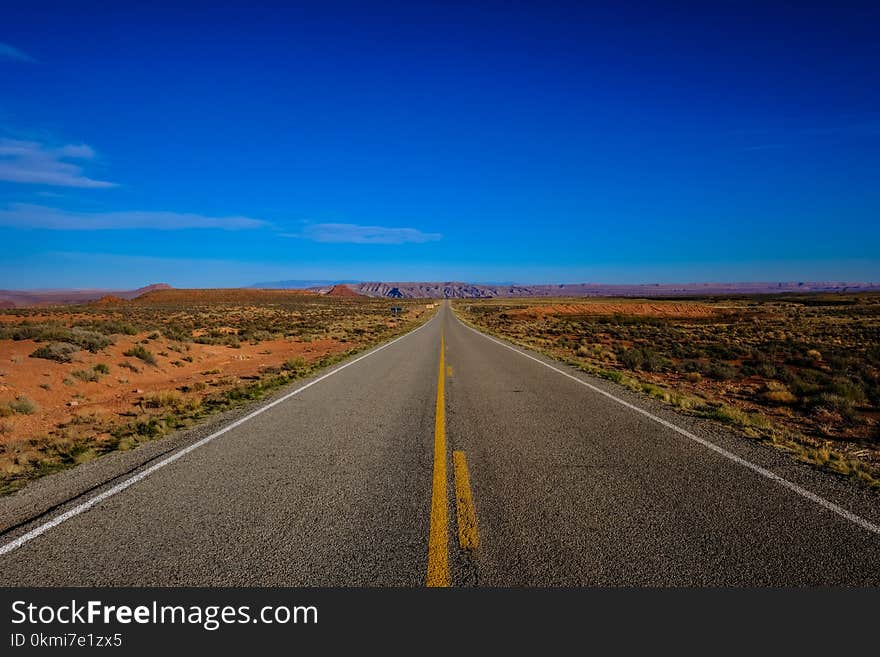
0, 139, 116, 189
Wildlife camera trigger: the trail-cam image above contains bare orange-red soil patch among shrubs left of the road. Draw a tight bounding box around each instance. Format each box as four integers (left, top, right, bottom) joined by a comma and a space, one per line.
0, 333, 351, 443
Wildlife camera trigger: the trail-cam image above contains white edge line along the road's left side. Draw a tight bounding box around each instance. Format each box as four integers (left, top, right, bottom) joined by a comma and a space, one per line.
0, 313, 439, 556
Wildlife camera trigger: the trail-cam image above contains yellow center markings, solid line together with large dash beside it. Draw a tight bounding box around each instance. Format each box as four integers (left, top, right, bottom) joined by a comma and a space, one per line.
426, 333, 479, 586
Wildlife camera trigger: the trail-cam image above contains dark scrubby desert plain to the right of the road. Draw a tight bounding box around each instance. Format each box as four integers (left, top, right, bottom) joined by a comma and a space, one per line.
456, 293, 880, 487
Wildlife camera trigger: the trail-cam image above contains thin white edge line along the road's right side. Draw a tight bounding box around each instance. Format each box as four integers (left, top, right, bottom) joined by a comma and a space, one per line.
453, 313, 880, 535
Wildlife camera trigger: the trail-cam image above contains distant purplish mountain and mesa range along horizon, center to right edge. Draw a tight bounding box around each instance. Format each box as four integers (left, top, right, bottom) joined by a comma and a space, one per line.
338, 282, 880, 299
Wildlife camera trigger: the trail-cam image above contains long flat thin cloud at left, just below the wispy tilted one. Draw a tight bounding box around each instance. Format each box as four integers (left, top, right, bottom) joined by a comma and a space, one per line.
0, 203, 269, 230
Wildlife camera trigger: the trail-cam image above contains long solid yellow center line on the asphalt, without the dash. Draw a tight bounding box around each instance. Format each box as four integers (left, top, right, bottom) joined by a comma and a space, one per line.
427, 333, 451, 586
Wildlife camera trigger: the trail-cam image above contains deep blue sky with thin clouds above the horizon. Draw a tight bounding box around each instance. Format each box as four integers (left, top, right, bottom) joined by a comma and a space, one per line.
0, 0, 880, 288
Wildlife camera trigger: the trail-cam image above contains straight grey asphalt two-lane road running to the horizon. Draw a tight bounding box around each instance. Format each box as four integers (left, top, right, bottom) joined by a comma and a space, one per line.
0, 304, 880, 586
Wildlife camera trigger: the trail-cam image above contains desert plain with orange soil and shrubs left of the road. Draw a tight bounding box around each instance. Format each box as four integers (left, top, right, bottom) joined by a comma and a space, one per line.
0, 286, 428, 493
